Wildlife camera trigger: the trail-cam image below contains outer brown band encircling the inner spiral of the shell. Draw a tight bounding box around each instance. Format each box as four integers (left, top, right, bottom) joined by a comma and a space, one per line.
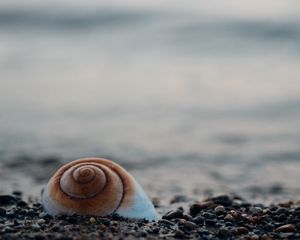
49, 158, 135, 215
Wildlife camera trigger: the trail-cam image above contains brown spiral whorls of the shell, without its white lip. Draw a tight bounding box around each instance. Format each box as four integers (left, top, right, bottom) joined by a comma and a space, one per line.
43, 158, 135, 215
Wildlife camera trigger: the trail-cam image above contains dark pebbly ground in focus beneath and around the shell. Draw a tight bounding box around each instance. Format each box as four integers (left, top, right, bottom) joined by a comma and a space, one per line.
0, 192, 300, 240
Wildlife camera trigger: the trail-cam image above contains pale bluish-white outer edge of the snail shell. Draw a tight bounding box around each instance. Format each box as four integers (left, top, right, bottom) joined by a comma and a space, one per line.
42, 158, 160, 221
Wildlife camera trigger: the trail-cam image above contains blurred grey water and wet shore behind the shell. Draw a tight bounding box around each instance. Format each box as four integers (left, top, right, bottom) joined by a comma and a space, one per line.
0, 0, 300, 201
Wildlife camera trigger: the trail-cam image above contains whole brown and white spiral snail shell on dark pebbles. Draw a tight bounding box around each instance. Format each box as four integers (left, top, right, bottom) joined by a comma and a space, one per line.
42, 158, 158, 221
